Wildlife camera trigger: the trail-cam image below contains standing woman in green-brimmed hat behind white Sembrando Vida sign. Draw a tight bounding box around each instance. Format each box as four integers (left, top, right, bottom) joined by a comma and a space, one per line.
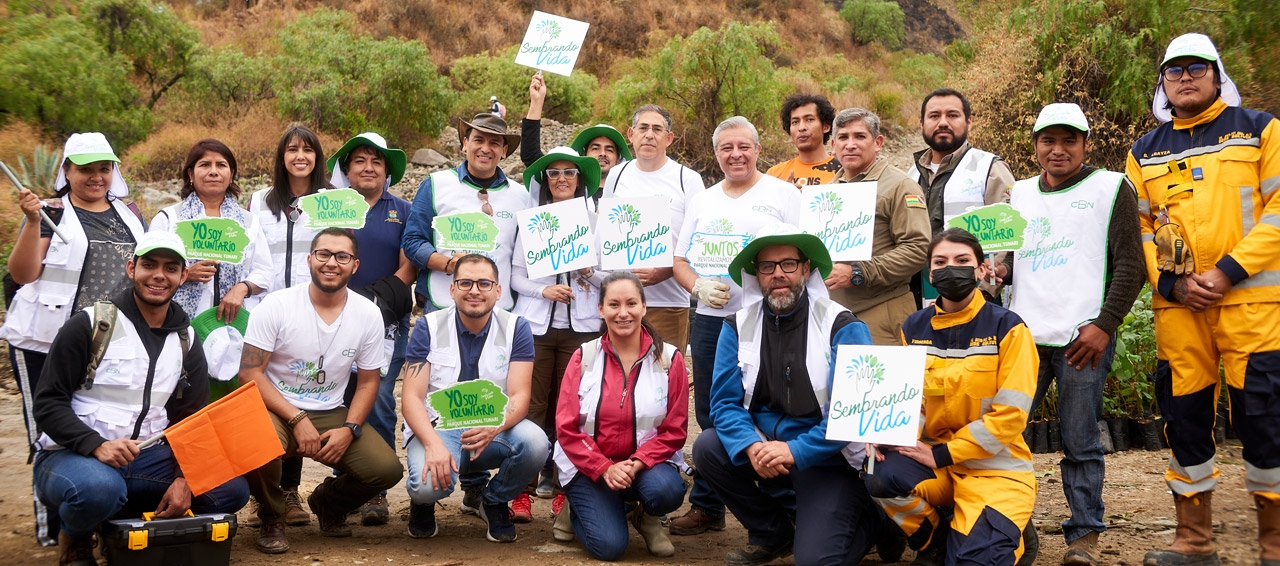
511, 147, 608, 512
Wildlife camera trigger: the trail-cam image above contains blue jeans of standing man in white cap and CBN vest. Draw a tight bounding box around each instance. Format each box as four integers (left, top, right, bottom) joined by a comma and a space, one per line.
1032, 338, 1116, 543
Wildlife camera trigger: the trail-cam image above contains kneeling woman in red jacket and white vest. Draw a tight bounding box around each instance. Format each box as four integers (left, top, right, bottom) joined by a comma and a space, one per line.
553, 271, 689, 561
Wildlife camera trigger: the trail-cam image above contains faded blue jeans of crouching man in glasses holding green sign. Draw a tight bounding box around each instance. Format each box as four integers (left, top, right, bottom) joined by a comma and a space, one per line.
404, 420, 550, 505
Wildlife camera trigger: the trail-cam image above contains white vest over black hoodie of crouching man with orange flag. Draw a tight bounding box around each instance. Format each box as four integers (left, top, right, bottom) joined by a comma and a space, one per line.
36, 306, 196, 449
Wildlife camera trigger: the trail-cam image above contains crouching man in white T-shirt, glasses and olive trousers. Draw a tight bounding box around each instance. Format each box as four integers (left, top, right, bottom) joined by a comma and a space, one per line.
239, 228, 404, 554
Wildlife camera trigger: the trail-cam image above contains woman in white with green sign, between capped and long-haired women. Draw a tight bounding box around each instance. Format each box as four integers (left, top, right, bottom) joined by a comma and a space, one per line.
151, 140, 274, 323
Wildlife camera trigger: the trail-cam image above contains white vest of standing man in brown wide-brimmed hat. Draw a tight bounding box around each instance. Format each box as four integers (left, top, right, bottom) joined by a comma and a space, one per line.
426, 169, 529, 311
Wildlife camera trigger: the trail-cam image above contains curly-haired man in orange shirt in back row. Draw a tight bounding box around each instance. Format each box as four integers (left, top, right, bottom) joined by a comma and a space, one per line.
767, 92, 840, 188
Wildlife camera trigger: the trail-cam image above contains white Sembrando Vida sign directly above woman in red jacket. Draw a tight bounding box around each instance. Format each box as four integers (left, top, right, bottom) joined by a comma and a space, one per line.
596, 196, 675, 270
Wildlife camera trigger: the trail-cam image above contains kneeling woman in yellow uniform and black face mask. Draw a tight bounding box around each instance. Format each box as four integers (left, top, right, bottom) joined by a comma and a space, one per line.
864, 228, 1038, 563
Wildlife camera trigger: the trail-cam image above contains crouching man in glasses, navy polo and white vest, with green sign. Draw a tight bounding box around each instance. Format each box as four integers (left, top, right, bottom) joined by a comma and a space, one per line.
401, 254, 550, 543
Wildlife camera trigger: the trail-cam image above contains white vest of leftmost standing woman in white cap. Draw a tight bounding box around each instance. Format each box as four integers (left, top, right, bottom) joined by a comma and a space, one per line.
0, 196, 146, 352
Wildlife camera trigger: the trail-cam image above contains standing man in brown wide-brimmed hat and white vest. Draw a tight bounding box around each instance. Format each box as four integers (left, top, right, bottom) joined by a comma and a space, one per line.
404, 113, 529, 312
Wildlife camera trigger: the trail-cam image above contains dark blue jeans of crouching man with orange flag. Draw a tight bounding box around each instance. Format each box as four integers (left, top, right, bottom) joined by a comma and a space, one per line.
35, 444, 248, 539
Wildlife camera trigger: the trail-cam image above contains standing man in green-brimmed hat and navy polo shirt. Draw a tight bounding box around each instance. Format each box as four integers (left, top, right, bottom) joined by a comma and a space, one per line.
329, 132, 417, 526
